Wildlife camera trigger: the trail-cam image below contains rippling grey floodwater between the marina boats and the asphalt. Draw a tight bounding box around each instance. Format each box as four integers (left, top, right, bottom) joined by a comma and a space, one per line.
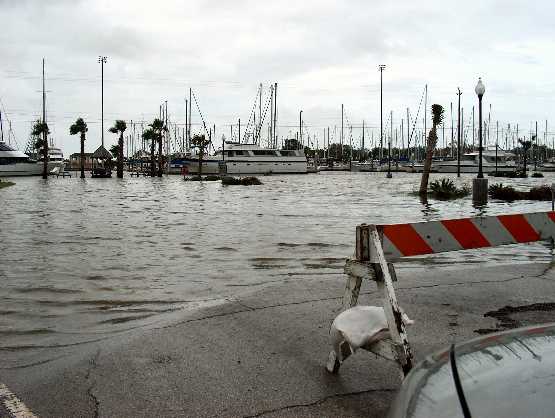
0, 173, 553, 362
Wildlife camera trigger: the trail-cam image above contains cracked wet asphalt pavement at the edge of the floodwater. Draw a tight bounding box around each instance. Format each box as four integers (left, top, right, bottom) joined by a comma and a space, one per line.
0, 264, 555, 417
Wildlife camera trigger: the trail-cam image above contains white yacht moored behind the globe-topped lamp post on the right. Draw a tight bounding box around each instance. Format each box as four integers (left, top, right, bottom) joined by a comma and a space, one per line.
432, 150, 518, 173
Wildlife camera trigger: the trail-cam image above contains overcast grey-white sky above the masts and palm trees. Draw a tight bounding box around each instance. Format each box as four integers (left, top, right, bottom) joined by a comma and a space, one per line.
0, 0, 555, 156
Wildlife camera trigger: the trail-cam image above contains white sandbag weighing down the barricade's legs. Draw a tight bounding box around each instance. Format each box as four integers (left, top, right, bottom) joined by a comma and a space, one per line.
330, 306, 414, 360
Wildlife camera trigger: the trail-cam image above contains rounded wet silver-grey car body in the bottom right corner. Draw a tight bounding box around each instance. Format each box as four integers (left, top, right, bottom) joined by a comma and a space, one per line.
390, 323, 555, 418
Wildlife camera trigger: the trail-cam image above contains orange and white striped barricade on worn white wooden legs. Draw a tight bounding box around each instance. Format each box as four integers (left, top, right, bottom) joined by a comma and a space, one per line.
326, 211, 555, 376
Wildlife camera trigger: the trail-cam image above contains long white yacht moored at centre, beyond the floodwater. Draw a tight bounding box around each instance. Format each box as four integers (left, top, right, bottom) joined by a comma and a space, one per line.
180, 142, 307, 175
